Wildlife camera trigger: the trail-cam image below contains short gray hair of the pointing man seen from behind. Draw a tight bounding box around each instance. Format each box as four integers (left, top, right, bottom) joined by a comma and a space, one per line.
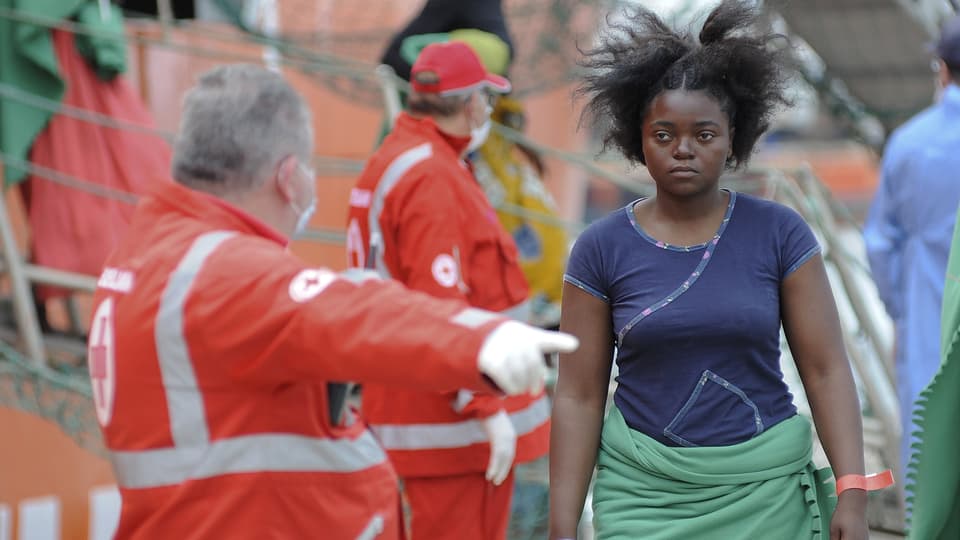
173, 64, 313, 194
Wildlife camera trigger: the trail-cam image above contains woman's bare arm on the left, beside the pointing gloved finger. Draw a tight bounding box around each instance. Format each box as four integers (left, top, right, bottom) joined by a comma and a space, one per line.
550, 283, 613, 539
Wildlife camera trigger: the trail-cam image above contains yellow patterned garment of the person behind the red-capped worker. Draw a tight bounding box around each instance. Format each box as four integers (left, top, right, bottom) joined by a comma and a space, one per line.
474, 97, 567, 324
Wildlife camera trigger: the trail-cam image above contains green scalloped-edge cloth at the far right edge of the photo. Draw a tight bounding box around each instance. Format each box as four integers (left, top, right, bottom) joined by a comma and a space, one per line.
908, 217, 960, 540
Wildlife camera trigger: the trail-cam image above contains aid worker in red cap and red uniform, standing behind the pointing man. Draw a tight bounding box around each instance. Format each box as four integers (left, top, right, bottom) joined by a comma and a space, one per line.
347, 42, 550, 540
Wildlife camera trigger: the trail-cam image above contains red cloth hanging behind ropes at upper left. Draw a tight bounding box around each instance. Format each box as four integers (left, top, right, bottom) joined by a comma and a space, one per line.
24, 30, 170, 300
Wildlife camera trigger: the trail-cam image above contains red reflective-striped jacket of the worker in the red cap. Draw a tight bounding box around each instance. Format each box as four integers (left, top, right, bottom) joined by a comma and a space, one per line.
347, 113, 550, 476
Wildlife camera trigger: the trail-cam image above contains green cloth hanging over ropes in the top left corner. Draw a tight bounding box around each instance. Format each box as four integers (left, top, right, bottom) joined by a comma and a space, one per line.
0, 0, 126, 186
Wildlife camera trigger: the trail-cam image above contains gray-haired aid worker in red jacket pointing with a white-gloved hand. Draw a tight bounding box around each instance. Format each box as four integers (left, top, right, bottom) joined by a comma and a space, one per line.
89, 65, 576, 540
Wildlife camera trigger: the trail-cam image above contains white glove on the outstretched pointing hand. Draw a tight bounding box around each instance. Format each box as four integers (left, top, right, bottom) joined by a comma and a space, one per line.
477, 321, 580, 395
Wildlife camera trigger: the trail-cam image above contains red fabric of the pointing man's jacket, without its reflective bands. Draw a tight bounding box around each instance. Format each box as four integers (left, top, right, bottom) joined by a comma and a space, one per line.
91, 183, 502, 540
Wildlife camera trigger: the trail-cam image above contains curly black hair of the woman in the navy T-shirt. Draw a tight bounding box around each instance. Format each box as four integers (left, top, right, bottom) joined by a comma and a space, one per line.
577, 0, 789, 167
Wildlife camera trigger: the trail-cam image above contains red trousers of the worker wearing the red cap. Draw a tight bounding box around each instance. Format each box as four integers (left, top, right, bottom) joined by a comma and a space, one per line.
403, 471, 514, 540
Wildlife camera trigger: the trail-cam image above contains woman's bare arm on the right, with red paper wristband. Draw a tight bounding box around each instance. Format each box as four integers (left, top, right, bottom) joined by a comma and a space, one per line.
780, 255, 867, 540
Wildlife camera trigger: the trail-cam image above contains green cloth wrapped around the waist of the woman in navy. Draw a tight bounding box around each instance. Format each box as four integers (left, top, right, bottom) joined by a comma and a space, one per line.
593, 407, 836, 540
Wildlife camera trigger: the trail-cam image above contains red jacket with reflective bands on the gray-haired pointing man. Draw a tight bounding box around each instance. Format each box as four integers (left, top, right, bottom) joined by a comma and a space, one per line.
89, 184, 503, 540
